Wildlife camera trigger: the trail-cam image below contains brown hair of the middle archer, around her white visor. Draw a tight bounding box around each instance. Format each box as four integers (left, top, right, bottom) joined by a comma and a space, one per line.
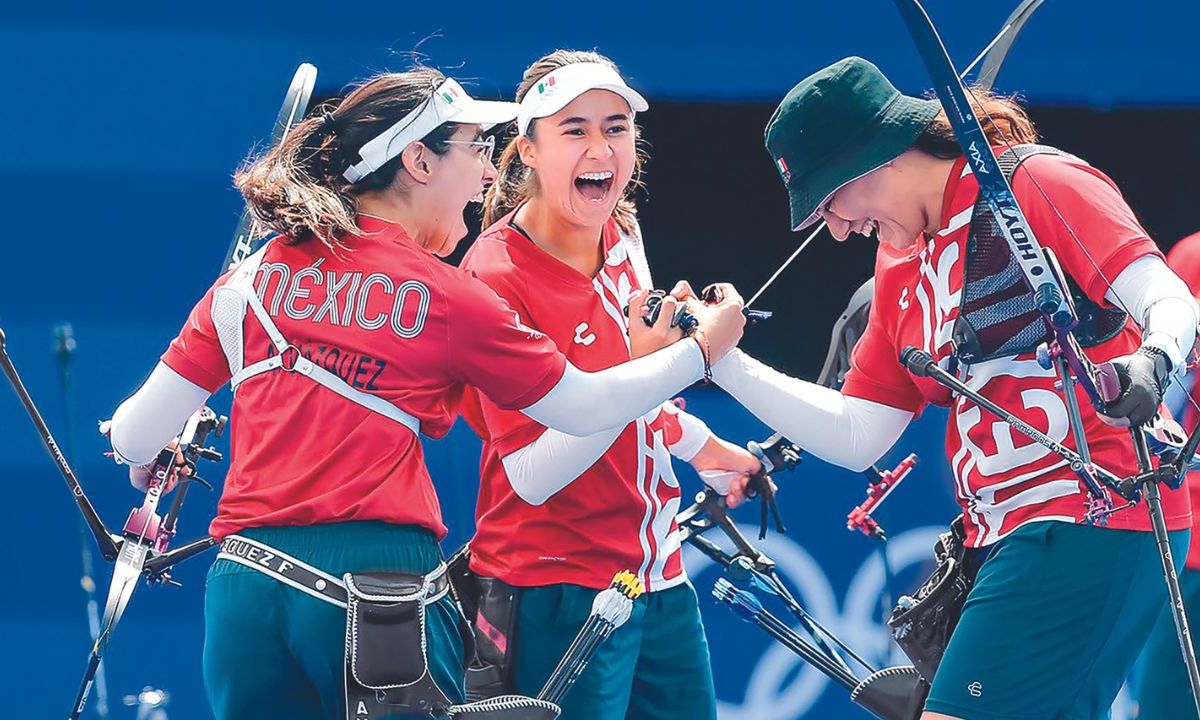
484, 50, 646, 233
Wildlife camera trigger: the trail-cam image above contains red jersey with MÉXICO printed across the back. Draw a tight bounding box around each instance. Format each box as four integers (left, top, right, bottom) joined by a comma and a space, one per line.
162, 217, 565, 539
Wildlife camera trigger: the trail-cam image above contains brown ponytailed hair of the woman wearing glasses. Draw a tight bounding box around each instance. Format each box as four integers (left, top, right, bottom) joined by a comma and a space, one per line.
234, 66, 455, 248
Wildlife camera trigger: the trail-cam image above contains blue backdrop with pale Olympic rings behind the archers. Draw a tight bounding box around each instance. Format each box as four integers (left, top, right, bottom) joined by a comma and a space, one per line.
0, 0, 1185, 720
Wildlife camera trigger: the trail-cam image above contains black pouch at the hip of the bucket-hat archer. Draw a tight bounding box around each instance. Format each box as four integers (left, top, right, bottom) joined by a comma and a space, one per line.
888, 516, 984, 683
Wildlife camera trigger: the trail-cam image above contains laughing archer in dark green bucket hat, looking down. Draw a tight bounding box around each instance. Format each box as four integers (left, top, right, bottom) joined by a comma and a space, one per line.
713, 58, 1196, 720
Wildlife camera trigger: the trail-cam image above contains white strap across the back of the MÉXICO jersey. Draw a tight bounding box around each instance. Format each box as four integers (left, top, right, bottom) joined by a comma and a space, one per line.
212, 242, 421, 433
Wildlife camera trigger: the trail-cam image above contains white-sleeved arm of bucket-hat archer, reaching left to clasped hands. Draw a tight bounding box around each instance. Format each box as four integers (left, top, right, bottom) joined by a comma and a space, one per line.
713, 350, 912, 470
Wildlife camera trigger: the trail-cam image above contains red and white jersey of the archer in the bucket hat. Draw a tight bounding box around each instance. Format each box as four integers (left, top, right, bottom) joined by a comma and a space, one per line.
842, 149, 1190, 547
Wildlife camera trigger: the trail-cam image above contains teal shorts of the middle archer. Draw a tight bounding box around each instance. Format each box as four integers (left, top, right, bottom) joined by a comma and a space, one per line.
512, 583, 716, 720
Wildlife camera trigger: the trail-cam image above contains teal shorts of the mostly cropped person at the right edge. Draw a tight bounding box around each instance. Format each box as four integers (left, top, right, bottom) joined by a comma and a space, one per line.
1134, 568, 1200, 720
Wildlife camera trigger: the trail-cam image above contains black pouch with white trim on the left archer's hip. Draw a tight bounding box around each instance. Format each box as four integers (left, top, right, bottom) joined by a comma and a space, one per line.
342, 572, 458, 720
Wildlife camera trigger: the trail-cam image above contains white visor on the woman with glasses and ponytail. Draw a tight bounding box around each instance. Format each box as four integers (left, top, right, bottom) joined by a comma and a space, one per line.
342, 78, 518, 182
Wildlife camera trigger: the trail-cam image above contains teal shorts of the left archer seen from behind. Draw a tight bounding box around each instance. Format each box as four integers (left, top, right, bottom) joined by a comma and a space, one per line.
204, 522, 463, 720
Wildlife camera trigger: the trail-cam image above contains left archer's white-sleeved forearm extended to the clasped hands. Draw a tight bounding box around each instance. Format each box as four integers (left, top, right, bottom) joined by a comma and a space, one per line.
521, 340, 704, 437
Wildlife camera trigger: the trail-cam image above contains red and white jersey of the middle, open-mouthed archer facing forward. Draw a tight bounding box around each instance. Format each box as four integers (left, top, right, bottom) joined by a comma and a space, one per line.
462, 214, 685, 590
